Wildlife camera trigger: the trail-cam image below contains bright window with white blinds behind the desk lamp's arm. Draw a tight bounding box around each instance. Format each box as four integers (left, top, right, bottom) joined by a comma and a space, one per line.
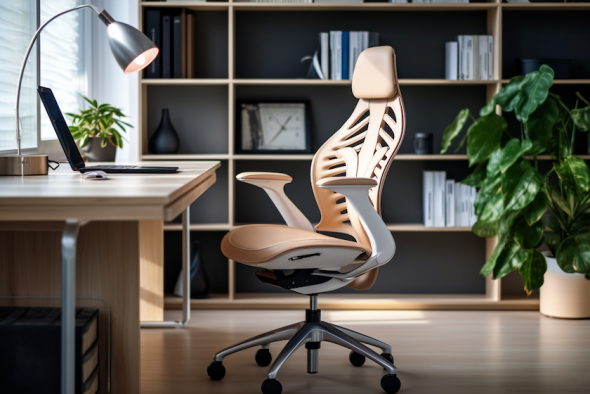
0, 0, 93, 151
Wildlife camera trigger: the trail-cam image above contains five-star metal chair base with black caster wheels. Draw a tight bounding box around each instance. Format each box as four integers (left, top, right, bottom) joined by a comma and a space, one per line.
207, 294, 401, 394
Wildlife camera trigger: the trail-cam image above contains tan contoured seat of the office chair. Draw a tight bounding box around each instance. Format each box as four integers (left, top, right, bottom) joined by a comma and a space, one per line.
221, 224, 367, 269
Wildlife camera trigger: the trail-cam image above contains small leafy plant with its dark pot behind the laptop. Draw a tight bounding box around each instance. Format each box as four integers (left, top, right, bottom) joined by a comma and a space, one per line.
66, 96, 133, 161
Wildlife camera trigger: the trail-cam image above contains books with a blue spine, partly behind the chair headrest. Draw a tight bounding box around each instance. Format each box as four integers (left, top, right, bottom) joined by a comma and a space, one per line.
320, 31, 379, 80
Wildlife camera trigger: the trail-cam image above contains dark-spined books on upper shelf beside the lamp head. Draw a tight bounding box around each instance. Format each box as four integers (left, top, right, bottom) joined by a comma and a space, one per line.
144, 9, 196, 78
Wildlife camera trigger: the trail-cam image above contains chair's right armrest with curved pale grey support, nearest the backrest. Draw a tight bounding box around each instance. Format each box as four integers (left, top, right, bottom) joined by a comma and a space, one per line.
316, 177, 395, 266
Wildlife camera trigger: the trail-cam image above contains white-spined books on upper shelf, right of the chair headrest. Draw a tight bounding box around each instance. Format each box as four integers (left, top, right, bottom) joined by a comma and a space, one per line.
445, 35, 494, 81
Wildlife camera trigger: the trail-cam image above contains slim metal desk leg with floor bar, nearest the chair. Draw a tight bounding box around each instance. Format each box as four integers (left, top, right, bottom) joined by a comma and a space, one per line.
141, 206, 191, 328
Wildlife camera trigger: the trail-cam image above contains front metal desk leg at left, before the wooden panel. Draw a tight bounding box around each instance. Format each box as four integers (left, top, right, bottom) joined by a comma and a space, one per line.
61, 220, 84, 394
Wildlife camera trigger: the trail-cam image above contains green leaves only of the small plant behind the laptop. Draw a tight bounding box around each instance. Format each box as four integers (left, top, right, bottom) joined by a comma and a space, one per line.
66, 96, 133, 148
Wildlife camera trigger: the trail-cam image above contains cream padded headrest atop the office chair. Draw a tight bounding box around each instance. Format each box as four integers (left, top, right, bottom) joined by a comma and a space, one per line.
352, 46, 397, 99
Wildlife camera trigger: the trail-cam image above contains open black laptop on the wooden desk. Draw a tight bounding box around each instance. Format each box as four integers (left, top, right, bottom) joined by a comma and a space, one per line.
37, 86, 178, 174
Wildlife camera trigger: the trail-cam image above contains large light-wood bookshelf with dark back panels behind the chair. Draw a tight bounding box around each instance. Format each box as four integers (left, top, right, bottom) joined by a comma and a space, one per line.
138, 1, 590, 310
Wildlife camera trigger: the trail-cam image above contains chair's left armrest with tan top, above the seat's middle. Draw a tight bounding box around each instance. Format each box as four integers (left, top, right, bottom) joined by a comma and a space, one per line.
236, 172, 314, 231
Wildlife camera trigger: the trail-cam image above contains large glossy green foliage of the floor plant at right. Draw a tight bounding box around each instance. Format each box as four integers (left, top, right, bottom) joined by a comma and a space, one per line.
441, 65, 590, 294
